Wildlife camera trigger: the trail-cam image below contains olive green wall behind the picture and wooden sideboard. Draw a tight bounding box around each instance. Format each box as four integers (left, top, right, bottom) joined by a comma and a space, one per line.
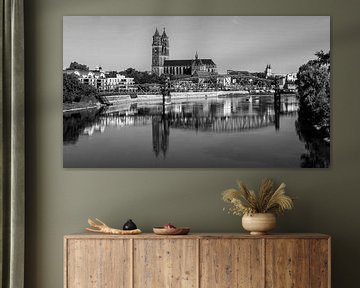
24, 0, 360, 288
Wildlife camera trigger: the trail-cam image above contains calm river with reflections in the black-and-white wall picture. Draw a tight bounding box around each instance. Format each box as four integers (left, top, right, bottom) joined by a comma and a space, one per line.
63, 96, 330, 168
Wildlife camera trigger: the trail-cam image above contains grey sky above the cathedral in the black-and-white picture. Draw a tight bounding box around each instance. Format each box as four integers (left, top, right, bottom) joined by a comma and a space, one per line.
63, 16, 330, 73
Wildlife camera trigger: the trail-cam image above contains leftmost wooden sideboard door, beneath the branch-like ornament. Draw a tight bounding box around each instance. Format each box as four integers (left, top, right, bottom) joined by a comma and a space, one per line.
65, 239, 132, 288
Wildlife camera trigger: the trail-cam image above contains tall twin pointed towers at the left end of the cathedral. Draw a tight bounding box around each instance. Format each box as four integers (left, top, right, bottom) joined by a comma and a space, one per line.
151, 28, 170, 76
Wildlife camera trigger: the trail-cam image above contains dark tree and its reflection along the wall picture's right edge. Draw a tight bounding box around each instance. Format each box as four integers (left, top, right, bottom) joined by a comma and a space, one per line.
295, 51, 330, 167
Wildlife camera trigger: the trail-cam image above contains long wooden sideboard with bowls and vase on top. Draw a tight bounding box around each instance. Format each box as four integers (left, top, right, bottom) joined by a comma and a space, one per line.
64, 233, 331, 288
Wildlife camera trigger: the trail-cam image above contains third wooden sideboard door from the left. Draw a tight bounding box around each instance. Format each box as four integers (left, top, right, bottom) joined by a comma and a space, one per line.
200, 239, 264, 288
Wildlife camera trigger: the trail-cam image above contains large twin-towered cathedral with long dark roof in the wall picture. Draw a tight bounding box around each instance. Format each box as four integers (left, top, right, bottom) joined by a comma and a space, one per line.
151, 28, 217, 77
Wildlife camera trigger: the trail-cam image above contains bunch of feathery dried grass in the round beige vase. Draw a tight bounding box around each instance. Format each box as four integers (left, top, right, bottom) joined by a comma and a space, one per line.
222, 179, 294, 216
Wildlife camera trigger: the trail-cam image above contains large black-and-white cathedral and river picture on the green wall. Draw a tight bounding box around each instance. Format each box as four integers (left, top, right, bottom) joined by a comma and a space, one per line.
63, 16, 331, 168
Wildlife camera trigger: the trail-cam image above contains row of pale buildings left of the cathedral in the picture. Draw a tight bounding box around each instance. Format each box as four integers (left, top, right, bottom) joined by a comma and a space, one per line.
63, 67, 136, 92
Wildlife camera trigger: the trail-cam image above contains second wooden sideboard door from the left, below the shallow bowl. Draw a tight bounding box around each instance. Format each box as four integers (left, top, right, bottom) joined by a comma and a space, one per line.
134, 239, 198, 288
